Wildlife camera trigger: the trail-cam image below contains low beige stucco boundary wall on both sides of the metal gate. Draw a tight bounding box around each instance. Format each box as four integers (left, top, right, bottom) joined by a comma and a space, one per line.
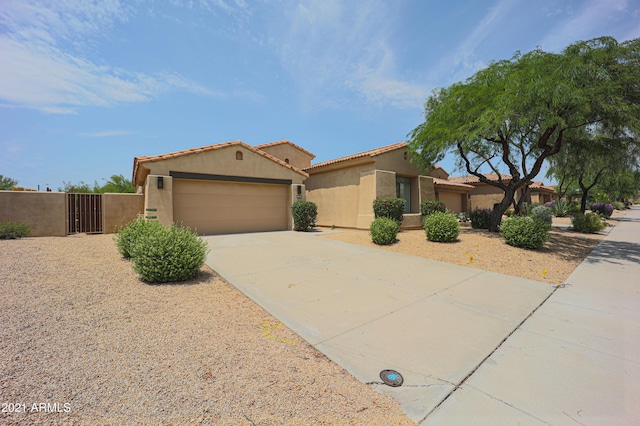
0, 191, 144, 237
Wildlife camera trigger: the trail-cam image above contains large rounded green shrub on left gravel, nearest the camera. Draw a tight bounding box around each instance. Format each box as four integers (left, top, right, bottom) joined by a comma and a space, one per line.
131, 224, 209, 283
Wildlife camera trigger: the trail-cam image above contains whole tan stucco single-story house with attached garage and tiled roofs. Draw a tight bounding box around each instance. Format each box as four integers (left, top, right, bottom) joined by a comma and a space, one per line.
132, 140, 473, 234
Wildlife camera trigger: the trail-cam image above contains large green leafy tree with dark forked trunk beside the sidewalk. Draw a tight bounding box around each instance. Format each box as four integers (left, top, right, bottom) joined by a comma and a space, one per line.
408, 37, 640, 232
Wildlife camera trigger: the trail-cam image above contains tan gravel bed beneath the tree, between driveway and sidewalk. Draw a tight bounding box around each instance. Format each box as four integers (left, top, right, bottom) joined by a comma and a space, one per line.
324, 211, 624, 285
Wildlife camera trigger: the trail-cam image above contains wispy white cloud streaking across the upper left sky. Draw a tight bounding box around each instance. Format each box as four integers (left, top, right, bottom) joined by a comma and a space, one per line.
0, 0, 220, 114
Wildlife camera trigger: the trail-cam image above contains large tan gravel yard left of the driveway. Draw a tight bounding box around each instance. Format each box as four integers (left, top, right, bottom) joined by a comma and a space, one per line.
0, 235, 413, 425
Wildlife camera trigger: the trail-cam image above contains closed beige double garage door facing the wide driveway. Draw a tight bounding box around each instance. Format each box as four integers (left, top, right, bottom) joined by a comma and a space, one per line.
173, 179, 289, 234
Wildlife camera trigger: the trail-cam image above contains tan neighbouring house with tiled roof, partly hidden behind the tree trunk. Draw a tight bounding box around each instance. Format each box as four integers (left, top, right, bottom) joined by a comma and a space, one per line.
449, 173, 558, 210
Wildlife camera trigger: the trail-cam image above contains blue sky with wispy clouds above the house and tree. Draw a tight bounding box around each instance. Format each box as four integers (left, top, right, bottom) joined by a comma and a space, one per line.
0, 0, 640, 190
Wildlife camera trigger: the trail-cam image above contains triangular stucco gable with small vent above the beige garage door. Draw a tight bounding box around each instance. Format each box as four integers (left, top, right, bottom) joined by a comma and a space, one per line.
141, 145, 305, 183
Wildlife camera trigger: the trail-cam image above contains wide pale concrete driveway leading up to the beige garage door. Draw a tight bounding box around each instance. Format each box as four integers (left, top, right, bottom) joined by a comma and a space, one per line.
205, 231, 554, 422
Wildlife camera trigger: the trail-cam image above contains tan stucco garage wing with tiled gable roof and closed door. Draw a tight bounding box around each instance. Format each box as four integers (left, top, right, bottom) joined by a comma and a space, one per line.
132, 141, 313, 234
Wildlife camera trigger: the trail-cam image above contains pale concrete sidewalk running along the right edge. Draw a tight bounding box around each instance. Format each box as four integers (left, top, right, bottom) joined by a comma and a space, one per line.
423, 207, 640, 425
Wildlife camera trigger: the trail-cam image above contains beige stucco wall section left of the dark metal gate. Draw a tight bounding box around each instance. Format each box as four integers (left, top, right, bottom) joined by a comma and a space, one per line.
0, 191, 67, 237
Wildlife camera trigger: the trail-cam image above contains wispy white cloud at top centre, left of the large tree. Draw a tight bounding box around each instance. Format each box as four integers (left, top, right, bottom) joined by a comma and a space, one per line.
272, 0, 426, 108
